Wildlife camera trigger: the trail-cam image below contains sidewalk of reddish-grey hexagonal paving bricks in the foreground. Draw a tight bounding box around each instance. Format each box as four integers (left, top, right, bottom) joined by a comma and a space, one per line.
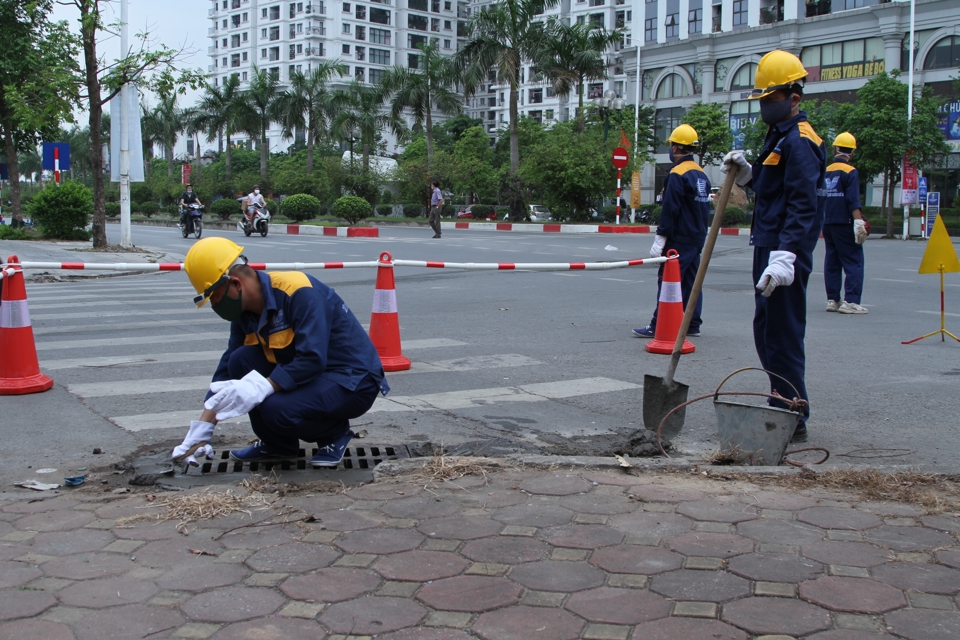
0, 470, 960, 640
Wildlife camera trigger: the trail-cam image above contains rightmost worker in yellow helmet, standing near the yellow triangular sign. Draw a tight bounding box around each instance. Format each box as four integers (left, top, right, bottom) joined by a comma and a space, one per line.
823, 131, 867, 314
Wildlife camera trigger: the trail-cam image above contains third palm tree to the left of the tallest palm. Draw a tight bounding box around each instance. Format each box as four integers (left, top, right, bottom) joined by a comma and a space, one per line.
279, 59, 349, 173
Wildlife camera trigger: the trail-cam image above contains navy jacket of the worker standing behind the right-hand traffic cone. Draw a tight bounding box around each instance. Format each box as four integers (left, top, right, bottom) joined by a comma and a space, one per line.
657, 156, 710, 248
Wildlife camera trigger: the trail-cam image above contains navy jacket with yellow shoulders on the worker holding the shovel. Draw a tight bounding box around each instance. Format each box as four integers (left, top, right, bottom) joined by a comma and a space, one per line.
750, 111, 827, 253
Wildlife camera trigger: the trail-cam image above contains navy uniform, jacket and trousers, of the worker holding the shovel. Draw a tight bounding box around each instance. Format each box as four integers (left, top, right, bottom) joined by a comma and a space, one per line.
749, 111, 827, 423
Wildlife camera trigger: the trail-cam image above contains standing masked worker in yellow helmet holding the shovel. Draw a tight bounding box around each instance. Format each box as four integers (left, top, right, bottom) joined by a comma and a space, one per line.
723, 50, 827, 442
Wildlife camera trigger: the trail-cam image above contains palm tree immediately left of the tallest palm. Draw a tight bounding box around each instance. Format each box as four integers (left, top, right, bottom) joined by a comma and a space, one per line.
381, 39, 463, 170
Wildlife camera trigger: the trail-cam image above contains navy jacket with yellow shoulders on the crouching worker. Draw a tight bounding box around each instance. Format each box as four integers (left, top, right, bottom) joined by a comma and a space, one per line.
208, 271, 390, 395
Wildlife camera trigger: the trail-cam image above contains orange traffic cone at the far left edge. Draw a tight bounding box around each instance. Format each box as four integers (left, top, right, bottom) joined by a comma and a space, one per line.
0, 256, 53, 396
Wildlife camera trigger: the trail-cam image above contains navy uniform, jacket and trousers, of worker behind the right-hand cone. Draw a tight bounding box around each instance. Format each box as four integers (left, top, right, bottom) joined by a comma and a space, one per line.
650, 156, 710, 333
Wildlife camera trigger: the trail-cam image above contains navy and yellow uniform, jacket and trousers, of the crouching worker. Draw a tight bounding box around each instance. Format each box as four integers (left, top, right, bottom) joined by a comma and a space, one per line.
207, 271, 390, 454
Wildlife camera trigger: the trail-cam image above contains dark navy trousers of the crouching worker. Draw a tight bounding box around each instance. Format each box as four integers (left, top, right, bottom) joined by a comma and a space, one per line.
228, 346, 379, 453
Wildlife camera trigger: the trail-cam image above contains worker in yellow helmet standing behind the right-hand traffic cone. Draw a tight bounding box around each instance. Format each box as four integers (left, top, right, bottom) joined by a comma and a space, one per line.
633, 124, 710, 338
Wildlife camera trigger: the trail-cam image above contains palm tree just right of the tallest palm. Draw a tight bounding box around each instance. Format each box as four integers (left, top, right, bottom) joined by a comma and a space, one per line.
536, 19, 623, 133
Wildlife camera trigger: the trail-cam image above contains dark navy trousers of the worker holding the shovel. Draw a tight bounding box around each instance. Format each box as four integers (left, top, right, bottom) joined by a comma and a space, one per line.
753, 247, 813, 424
